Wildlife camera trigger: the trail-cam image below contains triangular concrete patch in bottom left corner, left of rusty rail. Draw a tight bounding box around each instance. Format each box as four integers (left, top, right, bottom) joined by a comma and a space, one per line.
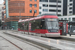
0, 33, 19, 50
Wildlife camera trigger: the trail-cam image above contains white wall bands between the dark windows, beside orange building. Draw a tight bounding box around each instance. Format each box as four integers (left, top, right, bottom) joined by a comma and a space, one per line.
39, 0, 63, 15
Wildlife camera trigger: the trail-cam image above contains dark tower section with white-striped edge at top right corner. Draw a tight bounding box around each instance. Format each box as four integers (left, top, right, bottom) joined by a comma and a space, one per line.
63, 0, 75, 16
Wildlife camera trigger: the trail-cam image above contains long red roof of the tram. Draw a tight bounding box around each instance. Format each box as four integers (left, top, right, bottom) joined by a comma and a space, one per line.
18, 14, 58, 22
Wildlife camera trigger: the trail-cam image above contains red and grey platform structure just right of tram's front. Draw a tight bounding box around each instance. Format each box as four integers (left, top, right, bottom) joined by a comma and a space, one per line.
59, 20, 68, 35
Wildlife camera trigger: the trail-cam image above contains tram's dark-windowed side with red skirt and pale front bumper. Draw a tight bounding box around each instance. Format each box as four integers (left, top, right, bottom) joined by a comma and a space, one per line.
18, 19, 60, 37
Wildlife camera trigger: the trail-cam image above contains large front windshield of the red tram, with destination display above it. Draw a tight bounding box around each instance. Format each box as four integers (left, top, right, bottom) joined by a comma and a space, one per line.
47, 19, 59, 29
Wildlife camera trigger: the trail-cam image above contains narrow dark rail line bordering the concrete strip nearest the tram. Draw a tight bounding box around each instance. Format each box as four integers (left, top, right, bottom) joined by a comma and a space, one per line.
4, 32, 61, 50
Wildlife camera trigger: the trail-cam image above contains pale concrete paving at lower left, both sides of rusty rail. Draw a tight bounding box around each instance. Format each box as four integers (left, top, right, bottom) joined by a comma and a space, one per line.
0, 31, 41, 50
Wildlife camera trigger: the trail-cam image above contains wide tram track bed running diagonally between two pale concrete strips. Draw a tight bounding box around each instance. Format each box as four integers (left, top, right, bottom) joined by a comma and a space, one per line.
4, 32, 60, 50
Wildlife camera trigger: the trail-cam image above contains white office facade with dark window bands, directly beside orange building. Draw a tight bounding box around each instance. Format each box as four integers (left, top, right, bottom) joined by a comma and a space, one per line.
39, 0, 63, 16
